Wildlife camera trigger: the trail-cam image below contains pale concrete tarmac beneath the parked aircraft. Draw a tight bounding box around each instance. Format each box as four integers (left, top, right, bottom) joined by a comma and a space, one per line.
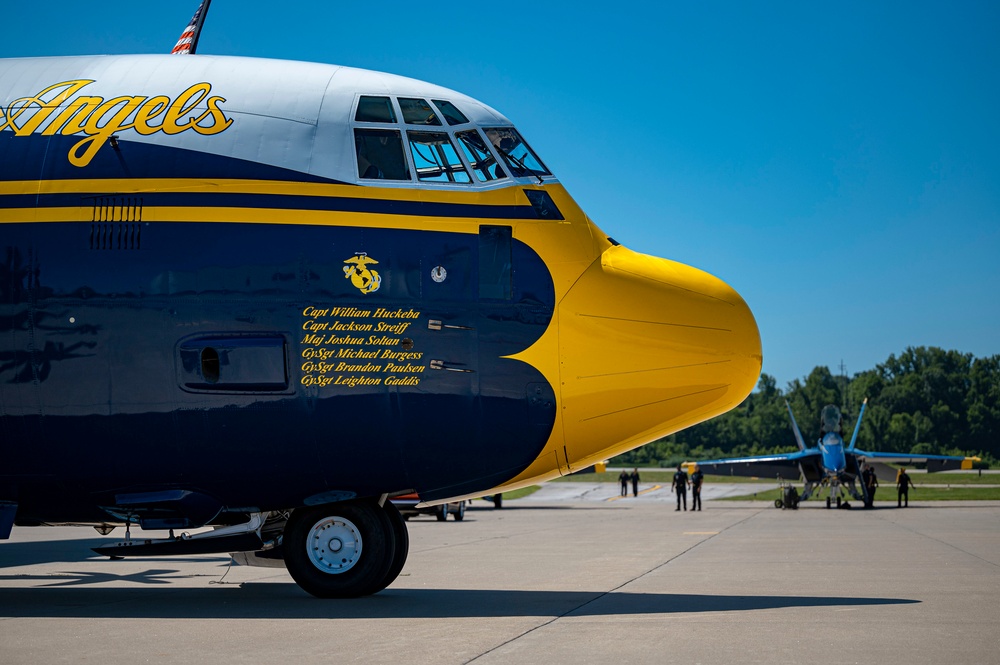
0, 483, 1000, 665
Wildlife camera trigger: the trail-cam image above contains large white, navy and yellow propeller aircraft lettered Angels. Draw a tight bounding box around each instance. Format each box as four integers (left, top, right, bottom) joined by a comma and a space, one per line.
0, 49, 761, 597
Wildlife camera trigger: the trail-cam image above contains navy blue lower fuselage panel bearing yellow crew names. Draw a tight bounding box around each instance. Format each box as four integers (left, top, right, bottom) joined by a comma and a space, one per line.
0, 218, 555, 524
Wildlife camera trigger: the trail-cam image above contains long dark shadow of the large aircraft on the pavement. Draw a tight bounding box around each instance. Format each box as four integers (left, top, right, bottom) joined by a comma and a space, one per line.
0, 588, 921, 619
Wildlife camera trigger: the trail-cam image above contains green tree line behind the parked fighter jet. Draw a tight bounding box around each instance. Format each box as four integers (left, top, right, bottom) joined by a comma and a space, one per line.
612, 347, 1000, 466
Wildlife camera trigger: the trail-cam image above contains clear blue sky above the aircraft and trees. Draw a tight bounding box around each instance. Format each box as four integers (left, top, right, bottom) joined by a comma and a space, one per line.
0, 0, 1000, 387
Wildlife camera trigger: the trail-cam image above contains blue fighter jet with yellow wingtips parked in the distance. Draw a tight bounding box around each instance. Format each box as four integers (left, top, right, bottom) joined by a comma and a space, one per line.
697, 398, 976, 508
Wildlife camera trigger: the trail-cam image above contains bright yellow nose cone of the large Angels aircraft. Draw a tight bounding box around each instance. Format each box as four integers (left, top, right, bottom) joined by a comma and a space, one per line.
558, 246, 763, 468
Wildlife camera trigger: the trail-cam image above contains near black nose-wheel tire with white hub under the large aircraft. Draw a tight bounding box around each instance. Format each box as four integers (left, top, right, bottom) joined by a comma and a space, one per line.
284, 500, 392, 598
